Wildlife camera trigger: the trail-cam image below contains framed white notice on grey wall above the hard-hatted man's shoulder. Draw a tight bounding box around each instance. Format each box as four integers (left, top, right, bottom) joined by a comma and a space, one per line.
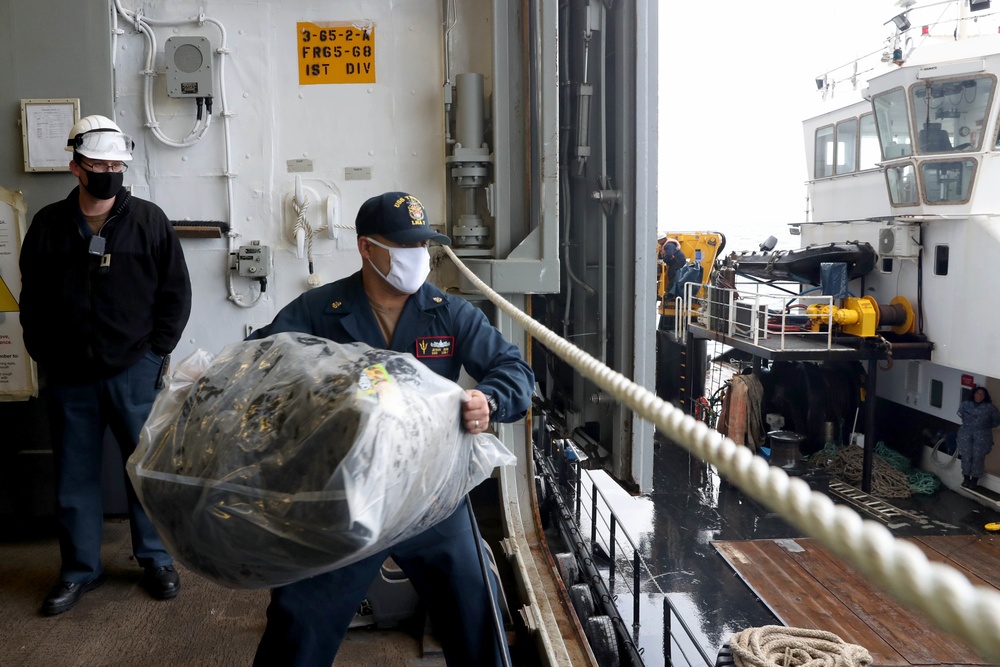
21, 98, 80, 171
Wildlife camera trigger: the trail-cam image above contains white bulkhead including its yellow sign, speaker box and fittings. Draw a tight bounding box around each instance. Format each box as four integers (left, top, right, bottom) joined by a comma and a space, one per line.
112, 0, 492, 366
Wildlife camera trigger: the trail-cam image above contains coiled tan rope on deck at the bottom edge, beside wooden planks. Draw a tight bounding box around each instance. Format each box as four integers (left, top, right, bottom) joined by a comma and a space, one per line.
729, 625, 872, 667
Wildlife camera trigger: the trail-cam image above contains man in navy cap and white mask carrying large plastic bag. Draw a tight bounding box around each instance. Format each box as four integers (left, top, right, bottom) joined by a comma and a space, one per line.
250, 192, 534, 667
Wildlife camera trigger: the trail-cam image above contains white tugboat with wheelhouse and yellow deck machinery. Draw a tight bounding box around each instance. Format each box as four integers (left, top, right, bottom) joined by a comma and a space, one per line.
664, 2, 1000, 505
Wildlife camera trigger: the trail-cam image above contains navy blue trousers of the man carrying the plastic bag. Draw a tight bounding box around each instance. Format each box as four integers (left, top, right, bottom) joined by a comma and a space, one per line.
254, 500, 507, 667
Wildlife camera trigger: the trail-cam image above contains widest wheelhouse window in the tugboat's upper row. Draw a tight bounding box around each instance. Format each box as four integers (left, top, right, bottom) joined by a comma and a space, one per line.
910, 76, 994, 155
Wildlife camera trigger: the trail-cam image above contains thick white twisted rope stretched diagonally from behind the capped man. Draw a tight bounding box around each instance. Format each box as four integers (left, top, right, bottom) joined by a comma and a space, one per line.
443, 246, 1000, 662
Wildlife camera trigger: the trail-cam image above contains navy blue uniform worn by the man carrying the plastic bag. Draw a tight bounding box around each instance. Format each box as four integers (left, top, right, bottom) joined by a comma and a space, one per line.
250, 272, 534, 667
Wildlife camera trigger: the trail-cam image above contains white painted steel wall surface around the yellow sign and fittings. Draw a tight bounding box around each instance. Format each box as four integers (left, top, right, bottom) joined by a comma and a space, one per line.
109, 0, 476, 359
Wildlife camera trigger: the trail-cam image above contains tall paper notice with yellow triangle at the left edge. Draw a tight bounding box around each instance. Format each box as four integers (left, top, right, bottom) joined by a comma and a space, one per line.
0, 188, 38, 401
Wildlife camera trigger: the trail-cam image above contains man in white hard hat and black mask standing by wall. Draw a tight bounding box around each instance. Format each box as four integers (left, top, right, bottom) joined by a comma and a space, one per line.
20, 116, 191, 615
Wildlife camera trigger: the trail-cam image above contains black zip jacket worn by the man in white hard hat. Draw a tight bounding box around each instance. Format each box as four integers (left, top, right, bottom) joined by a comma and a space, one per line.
20, 188, 191, 384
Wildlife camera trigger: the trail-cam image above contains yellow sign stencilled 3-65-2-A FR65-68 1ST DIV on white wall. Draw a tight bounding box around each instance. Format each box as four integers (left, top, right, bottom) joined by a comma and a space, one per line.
295, 22, 375, 86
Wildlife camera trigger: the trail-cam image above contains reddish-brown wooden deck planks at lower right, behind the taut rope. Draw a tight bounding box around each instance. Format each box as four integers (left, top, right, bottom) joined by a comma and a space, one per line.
714, 536, 1000, 666
